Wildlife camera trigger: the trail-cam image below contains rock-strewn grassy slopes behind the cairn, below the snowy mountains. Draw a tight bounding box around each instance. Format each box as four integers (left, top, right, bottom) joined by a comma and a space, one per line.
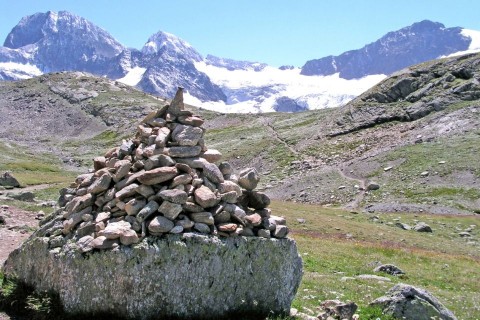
0, 54, 480, 213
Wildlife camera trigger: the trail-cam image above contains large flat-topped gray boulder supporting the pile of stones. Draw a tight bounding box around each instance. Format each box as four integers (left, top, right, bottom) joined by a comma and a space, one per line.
4, 233, 302, 319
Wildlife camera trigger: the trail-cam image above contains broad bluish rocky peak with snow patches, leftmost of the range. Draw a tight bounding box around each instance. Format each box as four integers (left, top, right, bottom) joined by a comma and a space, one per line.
0, 11, 125, 74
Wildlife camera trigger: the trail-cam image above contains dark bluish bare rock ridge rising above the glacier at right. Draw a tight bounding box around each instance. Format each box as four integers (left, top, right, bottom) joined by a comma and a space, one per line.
301, 20, 471, 79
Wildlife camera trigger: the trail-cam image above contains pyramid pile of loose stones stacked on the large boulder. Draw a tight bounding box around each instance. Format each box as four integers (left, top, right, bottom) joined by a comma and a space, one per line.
43, 88, 288, 252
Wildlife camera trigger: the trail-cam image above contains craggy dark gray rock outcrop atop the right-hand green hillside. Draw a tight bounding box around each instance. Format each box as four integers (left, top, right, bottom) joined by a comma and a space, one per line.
330, 54, 480, 137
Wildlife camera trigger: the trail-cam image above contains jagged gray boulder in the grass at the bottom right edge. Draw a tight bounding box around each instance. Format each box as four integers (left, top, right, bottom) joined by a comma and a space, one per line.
371, 283, 457, 320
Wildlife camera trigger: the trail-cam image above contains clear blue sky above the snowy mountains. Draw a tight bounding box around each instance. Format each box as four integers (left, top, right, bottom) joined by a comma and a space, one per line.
0, 0, 480, 66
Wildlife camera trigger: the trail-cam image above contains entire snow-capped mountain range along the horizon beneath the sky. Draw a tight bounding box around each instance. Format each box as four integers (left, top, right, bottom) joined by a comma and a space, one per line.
0, 11, 480, 112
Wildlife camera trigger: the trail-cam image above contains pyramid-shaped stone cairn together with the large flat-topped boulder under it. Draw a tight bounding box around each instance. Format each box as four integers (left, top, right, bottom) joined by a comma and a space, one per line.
4, 89, 302, 319
